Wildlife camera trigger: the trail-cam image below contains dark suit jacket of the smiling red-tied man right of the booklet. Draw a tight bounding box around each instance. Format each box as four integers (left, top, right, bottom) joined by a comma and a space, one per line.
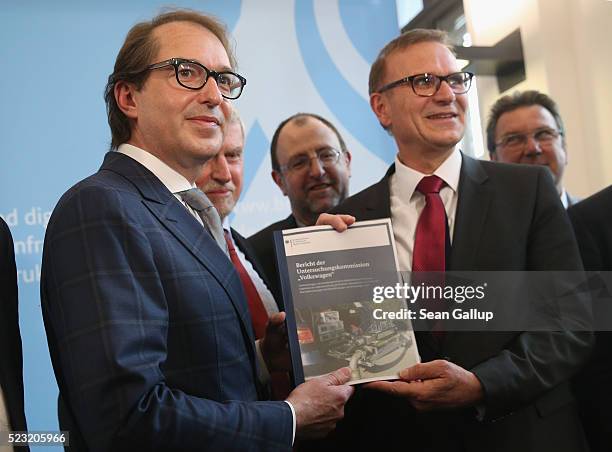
322, 156, 592, 452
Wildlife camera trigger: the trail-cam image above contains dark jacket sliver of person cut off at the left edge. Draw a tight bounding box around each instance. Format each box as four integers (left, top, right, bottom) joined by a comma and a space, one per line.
0, 218, 28, 444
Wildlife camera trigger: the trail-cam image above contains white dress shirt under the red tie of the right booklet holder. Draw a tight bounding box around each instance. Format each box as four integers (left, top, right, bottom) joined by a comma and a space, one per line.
389, 149, 461, 271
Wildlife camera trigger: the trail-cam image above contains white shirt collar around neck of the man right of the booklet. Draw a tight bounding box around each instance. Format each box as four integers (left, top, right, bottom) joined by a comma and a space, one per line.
395, 148, 462, 199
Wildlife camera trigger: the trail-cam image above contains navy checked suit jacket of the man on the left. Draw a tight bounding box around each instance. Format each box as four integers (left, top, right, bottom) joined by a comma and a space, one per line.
41, 152, 292, 451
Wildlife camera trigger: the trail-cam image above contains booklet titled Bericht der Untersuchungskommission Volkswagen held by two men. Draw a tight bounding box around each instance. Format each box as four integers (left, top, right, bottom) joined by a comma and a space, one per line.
274, 218, 420, 385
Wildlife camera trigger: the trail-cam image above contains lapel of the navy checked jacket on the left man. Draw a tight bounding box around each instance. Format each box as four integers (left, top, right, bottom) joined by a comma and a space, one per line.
101, 152, 255, 350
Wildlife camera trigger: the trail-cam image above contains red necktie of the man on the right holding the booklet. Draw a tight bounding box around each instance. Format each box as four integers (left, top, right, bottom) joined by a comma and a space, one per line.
412, 176, 446, 272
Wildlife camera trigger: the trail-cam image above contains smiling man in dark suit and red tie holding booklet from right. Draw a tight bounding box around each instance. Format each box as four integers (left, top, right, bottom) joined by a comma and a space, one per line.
320, 30, 592, 452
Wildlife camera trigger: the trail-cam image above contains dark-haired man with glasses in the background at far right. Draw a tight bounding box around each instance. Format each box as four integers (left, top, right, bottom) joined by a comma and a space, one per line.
487, 90, 579, 209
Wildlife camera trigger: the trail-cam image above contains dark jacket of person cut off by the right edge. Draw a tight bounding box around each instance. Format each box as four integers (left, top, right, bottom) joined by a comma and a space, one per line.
567, 186, 612, 452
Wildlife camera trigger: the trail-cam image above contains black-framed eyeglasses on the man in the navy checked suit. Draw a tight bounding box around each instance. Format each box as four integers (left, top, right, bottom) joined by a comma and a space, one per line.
142, 58, 246, 99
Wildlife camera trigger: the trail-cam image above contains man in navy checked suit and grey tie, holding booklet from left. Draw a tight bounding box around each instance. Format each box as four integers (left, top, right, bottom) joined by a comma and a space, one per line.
41, 10, 352, 451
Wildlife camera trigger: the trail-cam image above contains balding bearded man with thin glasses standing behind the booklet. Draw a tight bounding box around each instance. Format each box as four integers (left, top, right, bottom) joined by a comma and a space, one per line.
249, 113, 351, 300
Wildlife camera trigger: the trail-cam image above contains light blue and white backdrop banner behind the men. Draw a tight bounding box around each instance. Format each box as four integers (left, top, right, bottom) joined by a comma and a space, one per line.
0, 0, 399, 444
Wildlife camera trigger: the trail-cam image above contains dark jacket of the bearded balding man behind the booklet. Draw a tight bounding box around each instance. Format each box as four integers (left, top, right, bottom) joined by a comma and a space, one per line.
248, 215, 298, 310
